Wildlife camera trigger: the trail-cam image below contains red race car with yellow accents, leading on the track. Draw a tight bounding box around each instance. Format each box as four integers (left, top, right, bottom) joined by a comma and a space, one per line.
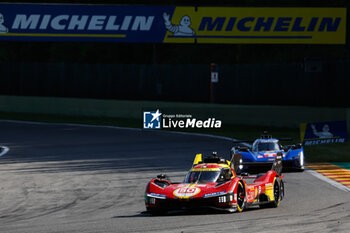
145, 152, 284, 215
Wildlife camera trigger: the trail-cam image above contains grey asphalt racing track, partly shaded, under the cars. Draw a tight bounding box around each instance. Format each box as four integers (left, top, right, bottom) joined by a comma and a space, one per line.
0, 121, 350, 233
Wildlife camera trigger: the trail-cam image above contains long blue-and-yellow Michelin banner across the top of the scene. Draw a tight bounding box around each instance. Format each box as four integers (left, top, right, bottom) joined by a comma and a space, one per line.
0, 4, 346, 44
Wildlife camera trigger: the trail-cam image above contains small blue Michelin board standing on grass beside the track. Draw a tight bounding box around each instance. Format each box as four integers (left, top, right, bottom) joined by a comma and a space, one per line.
300, 121, 348, 146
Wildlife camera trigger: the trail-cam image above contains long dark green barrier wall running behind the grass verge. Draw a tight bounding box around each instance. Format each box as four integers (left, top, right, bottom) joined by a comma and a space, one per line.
0, 96, 350, 128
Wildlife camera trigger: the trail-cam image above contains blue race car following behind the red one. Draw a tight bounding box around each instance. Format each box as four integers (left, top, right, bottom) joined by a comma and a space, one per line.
231, 134, 304, 171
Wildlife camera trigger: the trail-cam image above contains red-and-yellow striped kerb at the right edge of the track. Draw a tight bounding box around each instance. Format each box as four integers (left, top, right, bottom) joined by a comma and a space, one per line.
307, 163, 350, 188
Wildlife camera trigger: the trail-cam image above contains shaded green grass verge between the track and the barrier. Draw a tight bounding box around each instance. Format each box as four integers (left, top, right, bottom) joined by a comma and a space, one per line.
0, 112, 350, 162
